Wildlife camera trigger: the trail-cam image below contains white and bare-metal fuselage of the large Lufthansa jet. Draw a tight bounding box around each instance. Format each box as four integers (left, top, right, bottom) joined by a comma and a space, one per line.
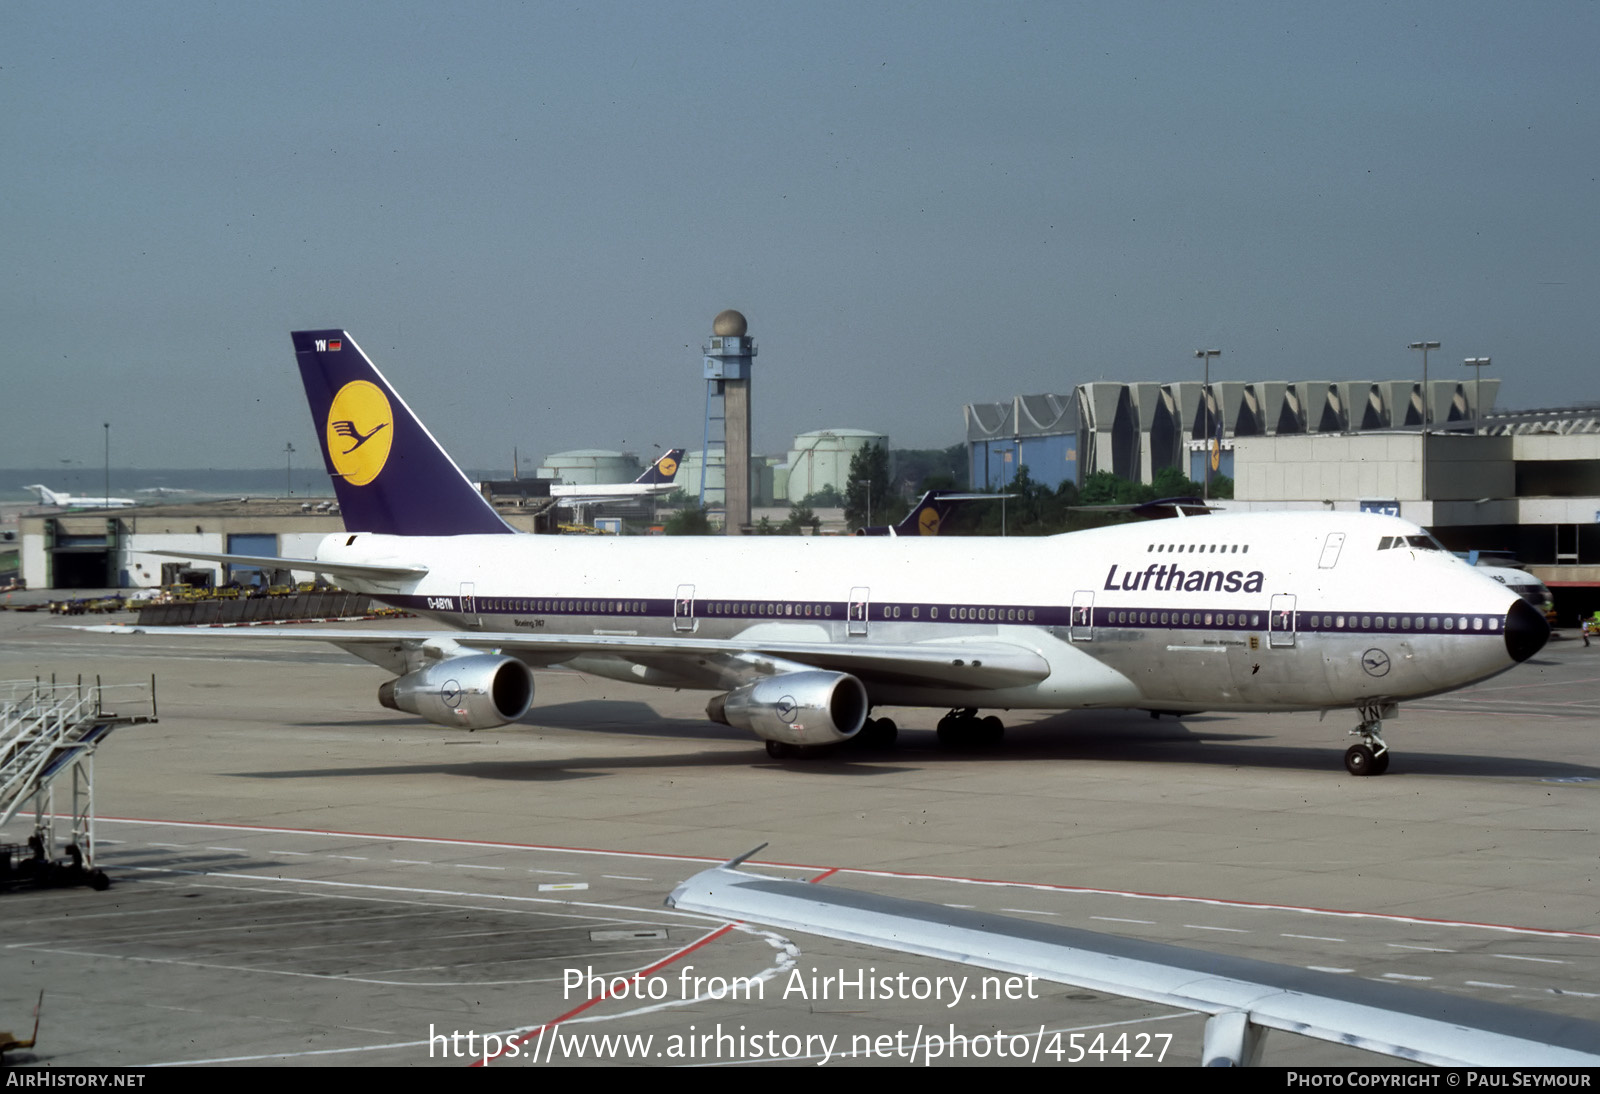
318, 513, 1542, 712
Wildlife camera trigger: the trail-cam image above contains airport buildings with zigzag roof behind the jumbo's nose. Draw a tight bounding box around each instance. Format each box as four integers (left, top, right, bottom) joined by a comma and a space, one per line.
965, 377, 1600, 610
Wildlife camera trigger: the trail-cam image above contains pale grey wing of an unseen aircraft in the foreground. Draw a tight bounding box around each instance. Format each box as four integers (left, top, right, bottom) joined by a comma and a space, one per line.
667, 848, 1600, 1067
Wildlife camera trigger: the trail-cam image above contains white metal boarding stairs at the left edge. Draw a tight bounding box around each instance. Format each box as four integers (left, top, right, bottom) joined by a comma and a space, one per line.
0, 677, 157, 889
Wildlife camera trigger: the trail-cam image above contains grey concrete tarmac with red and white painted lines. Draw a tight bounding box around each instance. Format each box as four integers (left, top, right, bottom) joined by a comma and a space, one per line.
0, 598, 1600, 1067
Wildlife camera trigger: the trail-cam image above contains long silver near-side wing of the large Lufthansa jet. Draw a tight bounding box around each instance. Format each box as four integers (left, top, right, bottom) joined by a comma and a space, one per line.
82, 623, 1050, 689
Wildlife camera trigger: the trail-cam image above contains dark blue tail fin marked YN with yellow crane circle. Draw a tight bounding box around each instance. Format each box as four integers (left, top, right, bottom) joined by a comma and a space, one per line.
291, 329, 514, 536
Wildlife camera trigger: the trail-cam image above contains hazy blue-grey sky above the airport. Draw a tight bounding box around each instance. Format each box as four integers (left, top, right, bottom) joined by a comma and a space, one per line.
0, 0, 1600, 467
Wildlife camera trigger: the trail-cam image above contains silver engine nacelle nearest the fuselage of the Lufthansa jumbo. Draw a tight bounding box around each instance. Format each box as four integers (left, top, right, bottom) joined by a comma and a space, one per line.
706, 670, 867, 745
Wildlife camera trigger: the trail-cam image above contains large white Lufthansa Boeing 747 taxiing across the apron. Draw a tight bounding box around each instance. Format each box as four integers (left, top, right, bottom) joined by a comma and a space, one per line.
134, 329, 1549, 776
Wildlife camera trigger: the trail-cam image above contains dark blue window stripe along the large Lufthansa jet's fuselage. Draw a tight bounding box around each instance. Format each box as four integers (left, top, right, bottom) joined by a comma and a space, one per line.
379, 595, 1504, 637
